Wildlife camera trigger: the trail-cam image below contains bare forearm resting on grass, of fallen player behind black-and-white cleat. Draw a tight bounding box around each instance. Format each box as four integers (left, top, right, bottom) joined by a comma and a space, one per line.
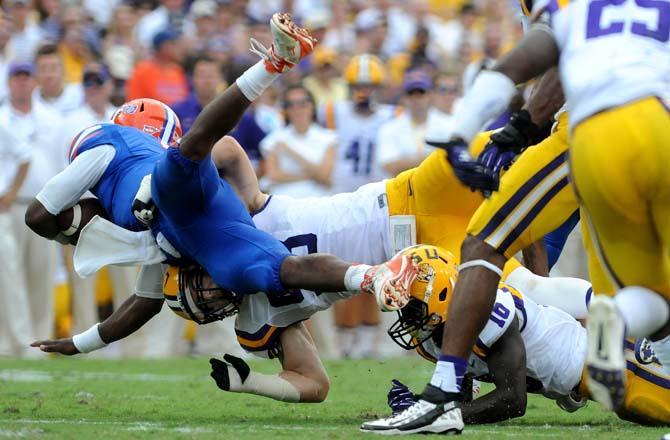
461, 388, 526, 425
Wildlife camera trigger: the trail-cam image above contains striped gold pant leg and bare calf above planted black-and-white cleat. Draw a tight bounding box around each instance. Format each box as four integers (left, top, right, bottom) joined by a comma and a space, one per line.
431, 121, 577, 393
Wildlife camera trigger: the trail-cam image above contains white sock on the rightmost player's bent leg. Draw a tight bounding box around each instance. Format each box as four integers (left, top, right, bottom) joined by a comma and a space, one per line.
614, 286, 670, 339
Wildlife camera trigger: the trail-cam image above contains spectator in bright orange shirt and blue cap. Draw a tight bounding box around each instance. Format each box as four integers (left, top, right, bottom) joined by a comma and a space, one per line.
127, 31, 188, 105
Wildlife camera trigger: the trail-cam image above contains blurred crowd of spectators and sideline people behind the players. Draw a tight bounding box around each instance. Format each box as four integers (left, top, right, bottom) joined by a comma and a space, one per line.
0, 0, 540, 357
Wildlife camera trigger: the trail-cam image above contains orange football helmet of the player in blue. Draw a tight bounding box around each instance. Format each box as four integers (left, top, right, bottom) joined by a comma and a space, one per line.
112, 98, 182, 147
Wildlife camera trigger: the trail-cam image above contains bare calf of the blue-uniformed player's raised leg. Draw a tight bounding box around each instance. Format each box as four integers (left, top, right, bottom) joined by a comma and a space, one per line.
179, 84, 251, 160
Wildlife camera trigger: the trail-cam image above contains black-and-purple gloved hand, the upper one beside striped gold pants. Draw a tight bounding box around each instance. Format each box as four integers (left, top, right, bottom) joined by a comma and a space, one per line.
477, 110, 538, 176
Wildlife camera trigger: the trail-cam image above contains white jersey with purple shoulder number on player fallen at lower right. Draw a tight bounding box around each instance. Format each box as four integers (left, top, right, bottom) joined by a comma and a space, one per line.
423, 287, 587, 396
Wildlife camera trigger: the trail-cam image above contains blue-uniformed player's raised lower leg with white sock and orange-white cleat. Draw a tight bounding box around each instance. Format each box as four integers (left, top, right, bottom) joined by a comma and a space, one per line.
179, 14, 315, 160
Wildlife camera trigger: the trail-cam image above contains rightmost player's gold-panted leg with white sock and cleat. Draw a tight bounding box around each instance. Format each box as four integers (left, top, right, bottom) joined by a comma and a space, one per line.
571, 99, 670, 408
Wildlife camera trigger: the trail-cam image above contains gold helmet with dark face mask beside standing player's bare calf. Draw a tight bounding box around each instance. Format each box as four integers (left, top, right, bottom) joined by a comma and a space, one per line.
388, 244, 458, 350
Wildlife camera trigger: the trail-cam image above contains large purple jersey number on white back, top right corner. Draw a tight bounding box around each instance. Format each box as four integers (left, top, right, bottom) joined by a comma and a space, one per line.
586, 0, 670, 43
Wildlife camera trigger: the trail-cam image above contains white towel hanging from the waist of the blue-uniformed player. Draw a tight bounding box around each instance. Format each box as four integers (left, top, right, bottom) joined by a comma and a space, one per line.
74, 215, 165, 278
